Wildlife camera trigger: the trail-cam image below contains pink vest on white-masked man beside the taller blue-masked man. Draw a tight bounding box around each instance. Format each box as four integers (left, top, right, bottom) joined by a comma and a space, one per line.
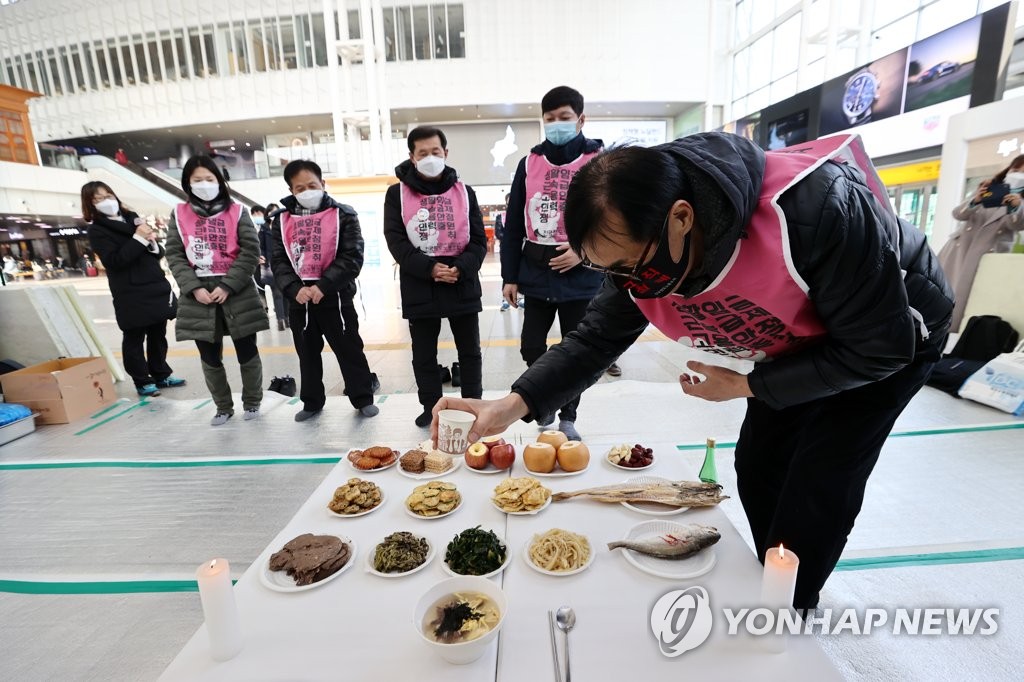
401, 182, 469, 256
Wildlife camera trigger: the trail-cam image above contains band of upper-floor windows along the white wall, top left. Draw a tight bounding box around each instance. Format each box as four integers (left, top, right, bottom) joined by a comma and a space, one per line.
0, 2, 466, 96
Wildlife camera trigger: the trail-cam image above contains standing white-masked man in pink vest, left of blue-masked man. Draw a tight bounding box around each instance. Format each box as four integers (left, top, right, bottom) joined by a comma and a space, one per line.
384, 126, 487, 426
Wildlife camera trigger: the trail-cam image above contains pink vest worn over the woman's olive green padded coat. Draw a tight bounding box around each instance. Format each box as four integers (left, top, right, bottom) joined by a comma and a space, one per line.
175, 202, 242, 278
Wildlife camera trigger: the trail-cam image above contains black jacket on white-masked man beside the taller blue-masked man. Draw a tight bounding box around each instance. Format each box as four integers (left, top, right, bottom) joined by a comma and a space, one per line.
384, 160, 487, 319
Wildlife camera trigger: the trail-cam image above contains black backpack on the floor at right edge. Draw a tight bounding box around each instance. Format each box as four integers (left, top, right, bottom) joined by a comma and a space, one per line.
928, 315, 1019, 397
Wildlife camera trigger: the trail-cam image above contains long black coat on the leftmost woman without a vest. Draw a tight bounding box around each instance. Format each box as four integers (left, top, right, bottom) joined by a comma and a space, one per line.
89, 211, 173, 330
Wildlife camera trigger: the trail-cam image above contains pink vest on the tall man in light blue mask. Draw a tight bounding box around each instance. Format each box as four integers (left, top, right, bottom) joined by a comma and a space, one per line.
525, 152, 597, 244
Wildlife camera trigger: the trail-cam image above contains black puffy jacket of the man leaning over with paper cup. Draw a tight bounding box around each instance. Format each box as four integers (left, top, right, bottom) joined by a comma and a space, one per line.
512, 133, 952, 417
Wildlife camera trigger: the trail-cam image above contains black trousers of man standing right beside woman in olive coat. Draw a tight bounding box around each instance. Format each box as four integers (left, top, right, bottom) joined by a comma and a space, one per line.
288, 295, 374, 411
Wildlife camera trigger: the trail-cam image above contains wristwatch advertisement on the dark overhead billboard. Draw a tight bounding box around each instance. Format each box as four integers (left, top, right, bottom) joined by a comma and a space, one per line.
818, 48, 907, 135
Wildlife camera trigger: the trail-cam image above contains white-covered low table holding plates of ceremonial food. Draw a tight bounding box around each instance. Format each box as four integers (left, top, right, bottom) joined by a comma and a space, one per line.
161, 441, 842, 682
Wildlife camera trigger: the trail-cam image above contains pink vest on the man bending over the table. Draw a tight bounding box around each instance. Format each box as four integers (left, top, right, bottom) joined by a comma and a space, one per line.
635, 135, 899, 361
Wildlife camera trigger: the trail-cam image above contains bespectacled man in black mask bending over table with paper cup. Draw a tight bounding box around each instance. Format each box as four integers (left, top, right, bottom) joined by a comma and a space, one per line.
434, 133, 952, 608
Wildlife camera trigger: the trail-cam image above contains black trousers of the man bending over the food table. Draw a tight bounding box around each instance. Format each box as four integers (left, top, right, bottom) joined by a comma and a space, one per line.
736, 360, 934, 608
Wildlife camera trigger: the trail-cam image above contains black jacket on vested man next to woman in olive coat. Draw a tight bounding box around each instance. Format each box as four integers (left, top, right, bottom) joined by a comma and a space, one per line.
270, 194, 364, 303
